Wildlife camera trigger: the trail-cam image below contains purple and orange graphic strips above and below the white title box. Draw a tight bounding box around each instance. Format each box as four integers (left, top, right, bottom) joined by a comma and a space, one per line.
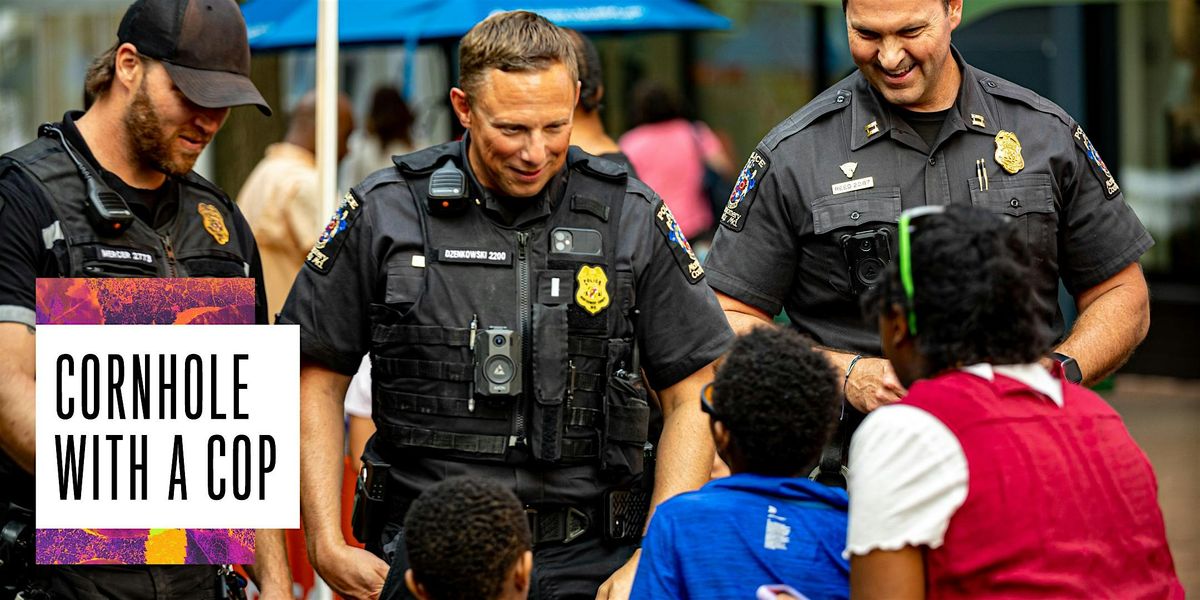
36, 278, 254, 564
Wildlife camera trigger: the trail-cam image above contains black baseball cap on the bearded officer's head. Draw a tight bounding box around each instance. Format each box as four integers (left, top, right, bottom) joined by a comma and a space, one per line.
116, 0, 271, 116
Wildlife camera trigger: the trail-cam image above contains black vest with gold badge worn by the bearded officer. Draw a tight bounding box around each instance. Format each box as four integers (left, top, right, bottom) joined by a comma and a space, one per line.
0, 131, 253, 277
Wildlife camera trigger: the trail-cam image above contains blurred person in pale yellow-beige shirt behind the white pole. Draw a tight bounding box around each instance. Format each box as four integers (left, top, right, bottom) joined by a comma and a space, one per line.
238, 91, 354, 322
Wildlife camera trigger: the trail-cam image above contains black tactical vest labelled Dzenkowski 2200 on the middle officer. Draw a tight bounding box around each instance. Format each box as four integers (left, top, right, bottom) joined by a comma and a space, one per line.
367, 143, 649, 474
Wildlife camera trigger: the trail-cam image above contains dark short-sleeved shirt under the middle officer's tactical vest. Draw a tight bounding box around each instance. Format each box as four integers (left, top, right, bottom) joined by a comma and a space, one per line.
281, 142, 733, 503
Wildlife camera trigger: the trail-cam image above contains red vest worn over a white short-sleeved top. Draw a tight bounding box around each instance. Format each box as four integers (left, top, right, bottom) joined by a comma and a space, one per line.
905, 372, 1183, 600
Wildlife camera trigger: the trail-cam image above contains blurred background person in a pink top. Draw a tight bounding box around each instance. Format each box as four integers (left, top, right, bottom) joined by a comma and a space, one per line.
619, 82, 734, 239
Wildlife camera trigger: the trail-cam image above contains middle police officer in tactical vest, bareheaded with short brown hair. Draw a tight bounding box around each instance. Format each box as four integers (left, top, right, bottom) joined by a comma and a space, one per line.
282, 11, 732, 599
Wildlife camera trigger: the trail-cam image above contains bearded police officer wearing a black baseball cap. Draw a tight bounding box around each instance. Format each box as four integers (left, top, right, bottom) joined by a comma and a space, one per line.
0, 0, 290, 599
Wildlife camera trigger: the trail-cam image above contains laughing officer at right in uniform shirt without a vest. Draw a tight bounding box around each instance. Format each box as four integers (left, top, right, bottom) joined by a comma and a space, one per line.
704, 0, 1153, 482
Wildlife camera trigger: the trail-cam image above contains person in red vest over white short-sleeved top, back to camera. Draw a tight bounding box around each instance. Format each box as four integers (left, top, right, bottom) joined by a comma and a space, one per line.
846, 206, 1183, 599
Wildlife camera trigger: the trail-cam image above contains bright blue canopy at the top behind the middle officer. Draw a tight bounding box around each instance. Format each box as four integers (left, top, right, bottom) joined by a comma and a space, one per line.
242, 0, 731, 50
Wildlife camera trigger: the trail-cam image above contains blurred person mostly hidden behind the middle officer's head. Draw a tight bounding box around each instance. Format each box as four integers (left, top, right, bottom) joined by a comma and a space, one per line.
566, 29, 637, 178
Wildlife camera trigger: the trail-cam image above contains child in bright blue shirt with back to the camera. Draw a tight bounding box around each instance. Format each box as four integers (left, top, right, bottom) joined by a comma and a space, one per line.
631, 326, 850, 600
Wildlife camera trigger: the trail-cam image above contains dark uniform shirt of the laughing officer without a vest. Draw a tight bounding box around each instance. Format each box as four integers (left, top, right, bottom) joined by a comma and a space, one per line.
704, 49, 1153, 355
